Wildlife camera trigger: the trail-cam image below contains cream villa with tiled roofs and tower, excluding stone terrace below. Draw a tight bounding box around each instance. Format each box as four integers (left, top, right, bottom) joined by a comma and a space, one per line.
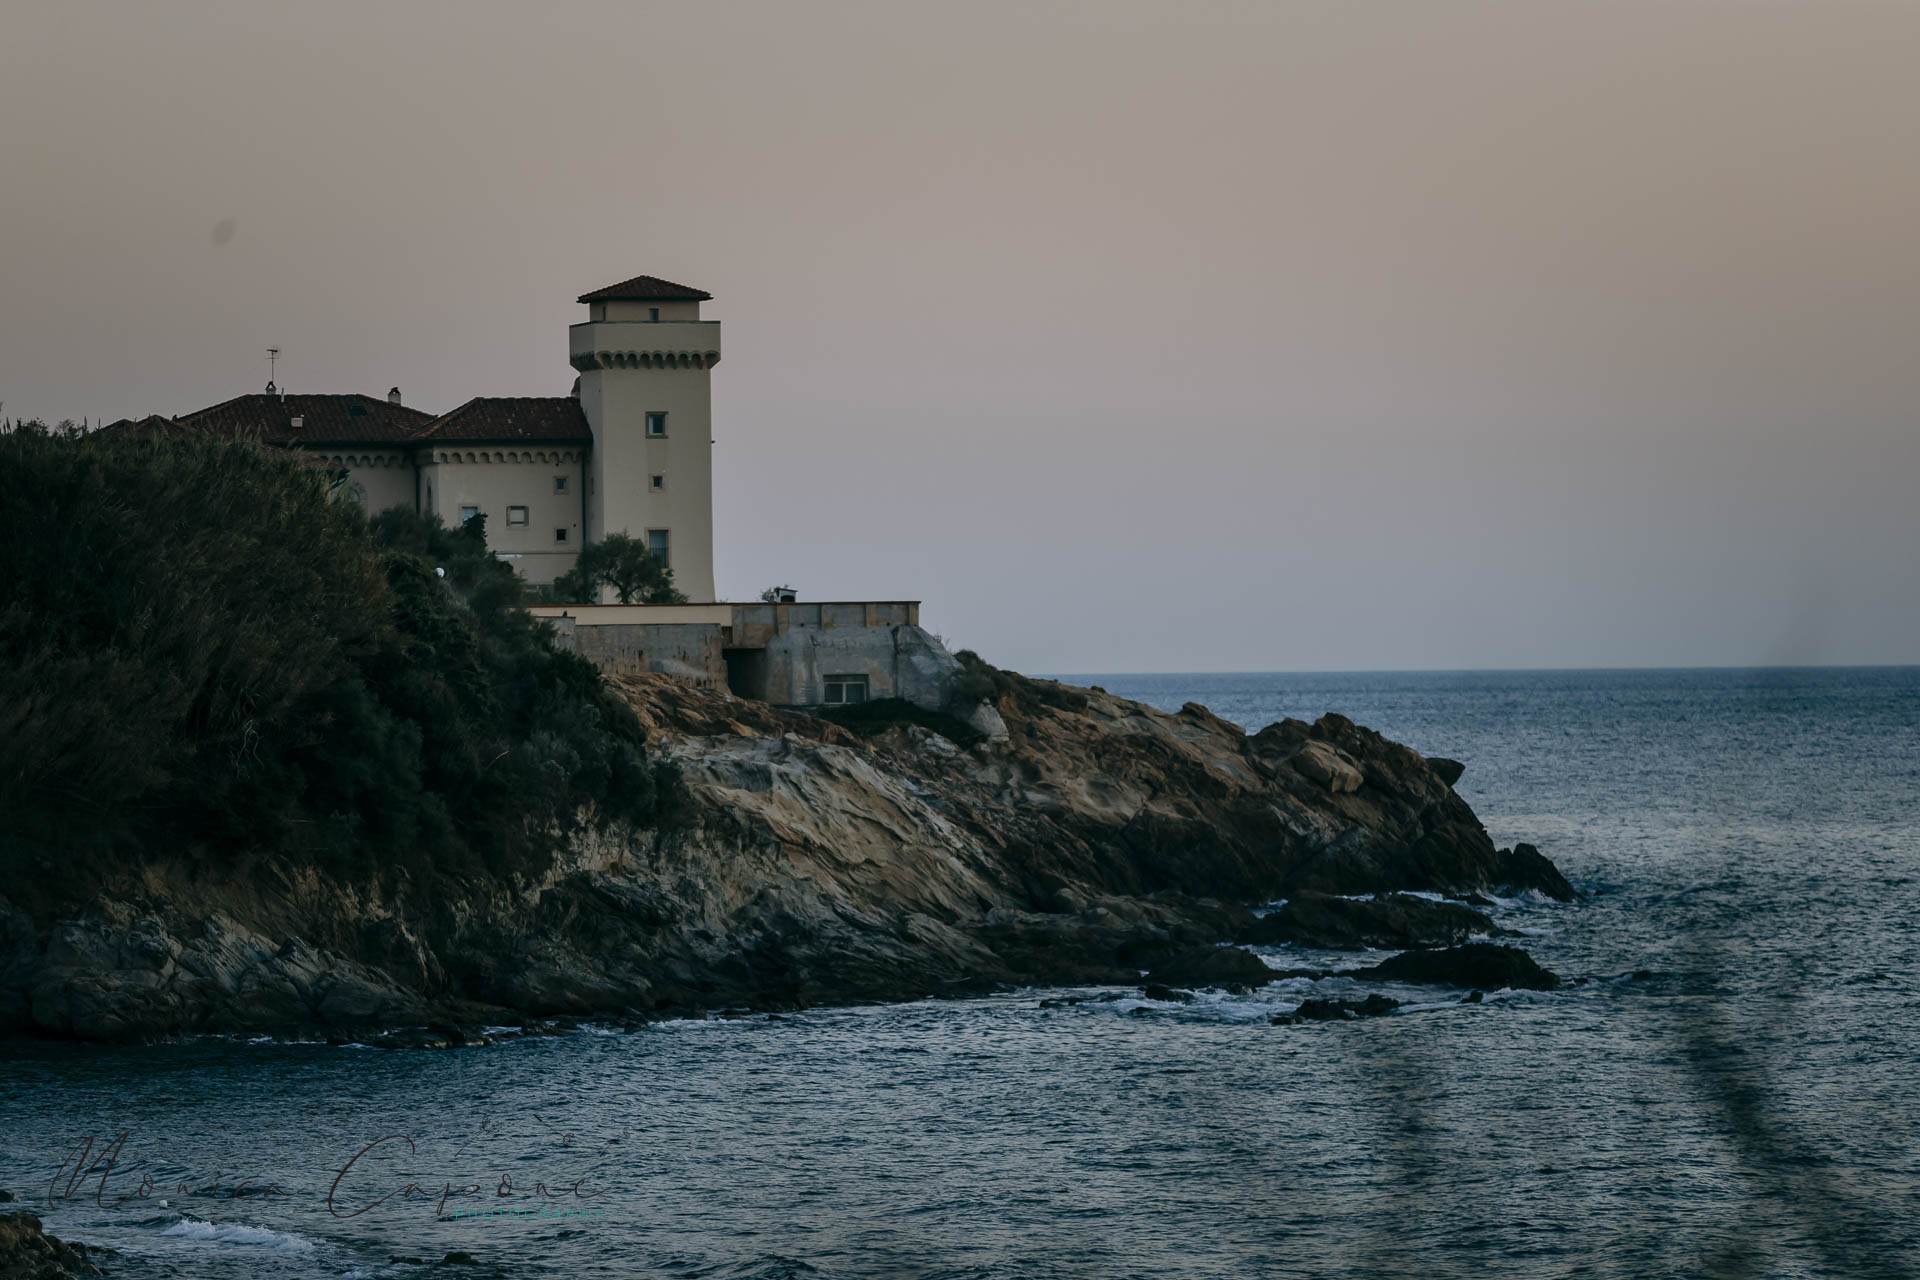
106, 276, 720, 601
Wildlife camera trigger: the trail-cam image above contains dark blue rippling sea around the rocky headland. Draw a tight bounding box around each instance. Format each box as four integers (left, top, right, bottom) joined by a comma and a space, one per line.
0, 668, 1920, 1280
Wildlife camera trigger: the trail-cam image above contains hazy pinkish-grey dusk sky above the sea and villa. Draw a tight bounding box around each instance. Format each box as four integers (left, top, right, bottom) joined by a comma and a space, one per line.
0, 0, 1920, 674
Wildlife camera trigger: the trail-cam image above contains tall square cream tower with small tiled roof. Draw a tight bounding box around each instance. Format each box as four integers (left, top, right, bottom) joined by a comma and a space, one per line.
568, 276, 720, 603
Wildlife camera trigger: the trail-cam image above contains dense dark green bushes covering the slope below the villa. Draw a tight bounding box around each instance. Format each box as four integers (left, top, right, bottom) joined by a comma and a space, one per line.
0, 424, 662, 898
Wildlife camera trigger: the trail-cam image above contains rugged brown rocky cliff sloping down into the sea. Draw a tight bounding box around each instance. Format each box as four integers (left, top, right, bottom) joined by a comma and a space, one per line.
0, 674, 1572, 1038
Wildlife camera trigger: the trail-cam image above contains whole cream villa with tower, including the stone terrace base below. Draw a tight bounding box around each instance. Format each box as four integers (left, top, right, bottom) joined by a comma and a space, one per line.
102, 276, 975, 710
